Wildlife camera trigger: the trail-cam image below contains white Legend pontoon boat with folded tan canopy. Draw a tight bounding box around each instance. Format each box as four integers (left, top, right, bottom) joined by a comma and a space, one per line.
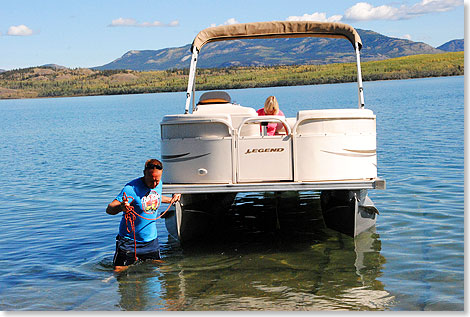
160, 21, 385, 242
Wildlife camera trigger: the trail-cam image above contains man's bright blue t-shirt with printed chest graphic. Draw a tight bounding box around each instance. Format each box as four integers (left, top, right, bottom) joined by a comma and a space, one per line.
116, 177, 162, 242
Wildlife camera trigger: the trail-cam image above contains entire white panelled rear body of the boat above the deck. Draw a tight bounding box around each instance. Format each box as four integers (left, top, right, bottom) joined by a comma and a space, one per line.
162, 108, 377, 184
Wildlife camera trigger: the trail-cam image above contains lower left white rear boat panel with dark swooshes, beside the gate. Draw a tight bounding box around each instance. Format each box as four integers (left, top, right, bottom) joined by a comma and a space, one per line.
162, 138, 232, 184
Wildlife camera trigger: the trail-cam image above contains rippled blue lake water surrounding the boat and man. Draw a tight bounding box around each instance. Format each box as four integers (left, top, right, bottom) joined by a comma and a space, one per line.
0, 77, 464, 311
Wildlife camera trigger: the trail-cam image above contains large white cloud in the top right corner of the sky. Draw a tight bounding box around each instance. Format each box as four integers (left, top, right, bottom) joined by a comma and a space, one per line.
345, 0, 464, 21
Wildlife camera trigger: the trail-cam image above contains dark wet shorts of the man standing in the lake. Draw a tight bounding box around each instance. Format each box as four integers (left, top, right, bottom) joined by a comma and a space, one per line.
113, 235, 160, 266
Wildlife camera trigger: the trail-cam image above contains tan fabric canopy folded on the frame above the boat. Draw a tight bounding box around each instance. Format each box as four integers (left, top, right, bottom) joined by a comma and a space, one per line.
191, 21, 362, 51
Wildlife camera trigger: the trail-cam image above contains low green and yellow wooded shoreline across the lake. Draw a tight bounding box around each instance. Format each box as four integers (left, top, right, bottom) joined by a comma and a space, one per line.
0, 52, 464, 99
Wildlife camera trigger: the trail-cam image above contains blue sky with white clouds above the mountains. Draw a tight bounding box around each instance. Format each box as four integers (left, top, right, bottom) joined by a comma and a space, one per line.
0, 0, 467, 70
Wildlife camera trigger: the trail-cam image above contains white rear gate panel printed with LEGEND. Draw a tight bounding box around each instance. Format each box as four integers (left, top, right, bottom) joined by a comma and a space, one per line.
238, 135, 292, 182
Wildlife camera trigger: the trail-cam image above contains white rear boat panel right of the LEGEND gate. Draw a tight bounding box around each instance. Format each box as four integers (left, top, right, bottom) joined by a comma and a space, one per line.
294, 109, 377, 181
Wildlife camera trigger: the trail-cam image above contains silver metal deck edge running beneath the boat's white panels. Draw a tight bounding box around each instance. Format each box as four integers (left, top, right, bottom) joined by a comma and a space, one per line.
162, 178, 386, 194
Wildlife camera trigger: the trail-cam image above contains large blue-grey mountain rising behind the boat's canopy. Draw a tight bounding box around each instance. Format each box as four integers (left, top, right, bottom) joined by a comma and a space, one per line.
93, 29, 443, 71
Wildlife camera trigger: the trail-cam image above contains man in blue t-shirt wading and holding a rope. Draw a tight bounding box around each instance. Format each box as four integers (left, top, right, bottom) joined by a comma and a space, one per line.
106, 159, 181, 272
